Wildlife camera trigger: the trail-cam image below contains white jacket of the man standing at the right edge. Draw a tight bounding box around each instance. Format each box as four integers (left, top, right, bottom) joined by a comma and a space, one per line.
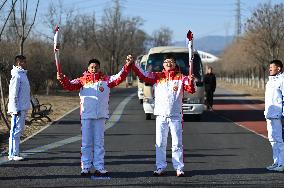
264, 74, 284, 119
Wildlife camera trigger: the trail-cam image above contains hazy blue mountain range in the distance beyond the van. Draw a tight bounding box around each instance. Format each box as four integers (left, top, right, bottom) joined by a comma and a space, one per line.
174, 36, 234, 56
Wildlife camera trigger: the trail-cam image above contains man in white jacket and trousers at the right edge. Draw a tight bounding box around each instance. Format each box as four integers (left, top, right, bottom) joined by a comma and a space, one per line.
264, 60, 284, 172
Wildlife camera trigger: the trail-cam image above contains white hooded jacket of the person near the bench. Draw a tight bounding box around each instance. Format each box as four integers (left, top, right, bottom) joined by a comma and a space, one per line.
8, 66, 31, 114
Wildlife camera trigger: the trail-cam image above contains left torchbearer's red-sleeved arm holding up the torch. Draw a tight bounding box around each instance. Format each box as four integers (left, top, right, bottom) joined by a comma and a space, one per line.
57, 72, 83, 91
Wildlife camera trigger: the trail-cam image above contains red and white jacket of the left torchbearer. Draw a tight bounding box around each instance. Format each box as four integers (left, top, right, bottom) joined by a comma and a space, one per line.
61, 66, 130, 119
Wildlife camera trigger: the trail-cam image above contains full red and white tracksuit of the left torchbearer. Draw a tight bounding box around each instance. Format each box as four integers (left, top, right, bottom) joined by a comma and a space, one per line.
61, 65, 130, 170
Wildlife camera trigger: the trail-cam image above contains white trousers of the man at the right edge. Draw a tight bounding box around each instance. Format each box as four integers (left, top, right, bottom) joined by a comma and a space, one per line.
266, 119, 284, 165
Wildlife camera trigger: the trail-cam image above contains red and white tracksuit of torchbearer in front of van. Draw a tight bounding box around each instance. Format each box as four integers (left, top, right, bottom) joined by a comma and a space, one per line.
132, 64, 195, 170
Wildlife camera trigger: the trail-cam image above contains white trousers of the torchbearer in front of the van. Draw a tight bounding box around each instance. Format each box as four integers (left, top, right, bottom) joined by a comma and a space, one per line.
156, 116, 184, 170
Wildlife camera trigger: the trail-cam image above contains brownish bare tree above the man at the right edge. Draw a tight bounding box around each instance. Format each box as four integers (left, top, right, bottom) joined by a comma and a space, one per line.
246, 3, 284, 82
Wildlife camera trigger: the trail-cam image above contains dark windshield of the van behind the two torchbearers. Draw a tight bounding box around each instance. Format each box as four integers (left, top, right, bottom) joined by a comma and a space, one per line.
146, 52, 203, 81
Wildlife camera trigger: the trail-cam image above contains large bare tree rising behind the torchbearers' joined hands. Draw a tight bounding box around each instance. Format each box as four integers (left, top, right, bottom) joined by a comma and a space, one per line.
96, 0, 145, 74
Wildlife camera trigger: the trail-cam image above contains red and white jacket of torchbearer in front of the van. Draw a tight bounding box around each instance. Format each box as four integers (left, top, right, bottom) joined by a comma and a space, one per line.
132, 64, 195, 117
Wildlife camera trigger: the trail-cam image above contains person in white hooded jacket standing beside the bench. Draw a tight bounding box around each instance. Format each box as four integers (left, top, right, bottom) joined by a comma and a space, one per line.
8, 55, 30, 161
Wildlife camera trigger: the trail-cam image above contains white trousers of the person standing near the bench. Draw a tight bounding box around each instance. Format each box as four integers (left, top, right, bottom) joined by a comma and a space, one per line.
9, 111, 26, 157
